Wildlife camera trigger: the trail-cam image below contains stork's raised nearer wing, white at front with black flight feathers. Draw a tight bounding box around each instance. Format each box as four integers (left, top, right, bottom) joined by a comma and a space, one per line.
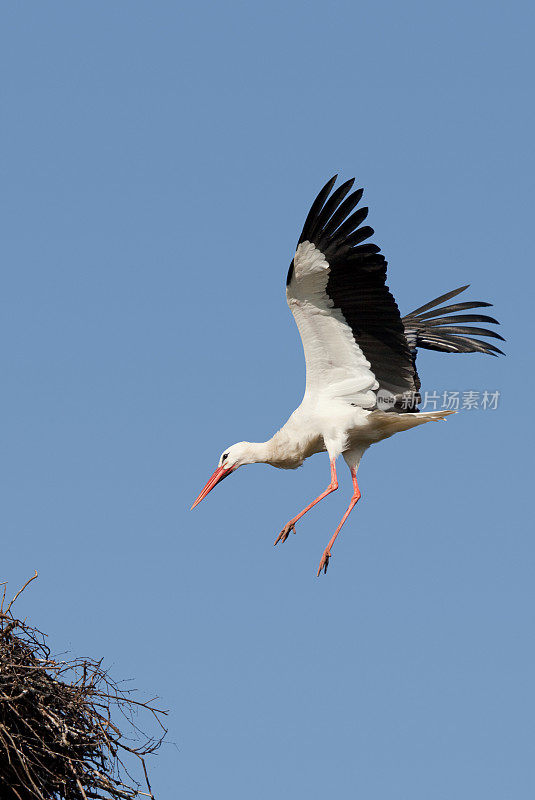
286, 175, 419, 411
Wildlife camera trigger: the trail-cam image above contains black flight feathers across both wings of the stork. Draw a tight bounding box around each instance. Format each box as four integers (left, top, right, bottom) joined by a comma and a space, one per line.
287, 175, 503, 411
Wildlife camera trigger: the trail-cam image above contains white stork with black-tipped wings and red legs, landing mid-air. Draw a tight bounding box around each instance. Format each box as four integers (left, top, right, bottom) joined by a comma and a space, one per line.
192, 175, 503, 576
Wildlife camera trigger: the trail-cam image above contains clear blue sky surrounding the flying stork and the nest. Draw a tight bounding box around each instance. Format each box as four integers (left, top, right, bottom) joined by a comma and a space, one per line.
0, 0, 535, 800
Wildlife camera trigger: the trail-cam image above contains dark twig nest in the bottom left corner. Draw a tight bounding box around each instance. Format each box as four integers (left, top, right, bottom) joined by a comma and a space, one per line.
0, 573, 166, 800
